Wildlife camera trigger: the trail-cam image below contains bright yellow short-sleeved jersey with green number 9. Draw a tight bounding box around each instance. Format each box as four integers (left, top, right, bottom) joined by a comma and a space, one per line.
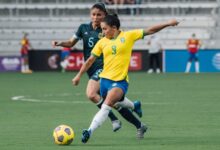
91, 29, 144, 81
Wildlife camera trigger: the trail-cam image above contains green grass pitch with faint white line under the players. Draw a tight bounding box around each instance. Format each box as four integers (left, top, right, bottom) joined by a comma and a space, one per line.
0, 72, 220, 150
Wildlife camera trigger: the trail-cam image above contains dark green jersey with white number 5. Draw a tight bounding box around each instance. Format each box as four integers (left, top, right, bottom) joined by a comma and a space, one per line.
74, 23, 103, 77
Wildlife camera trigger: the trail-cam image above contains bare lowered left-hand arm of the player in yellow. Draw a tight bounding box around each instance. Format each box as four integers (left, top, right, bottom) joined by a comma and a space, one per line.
72, 55, 96, 85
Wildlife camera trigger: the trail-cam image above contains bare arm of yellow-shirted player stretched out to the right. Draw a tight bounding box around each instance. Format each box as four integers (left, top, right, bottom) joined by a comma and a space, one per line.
144, 19, 179, 36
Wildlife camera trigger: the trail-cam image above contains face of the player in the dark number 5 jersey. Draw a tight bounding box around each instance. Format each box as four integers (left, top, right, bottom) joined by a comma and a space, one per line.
90, 8, 105, 26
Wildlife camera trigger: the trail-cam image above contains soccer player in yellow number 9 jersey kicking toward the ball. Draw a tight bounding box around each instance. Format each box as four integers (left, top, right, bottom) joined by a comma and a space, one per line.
72, 15, 178, 143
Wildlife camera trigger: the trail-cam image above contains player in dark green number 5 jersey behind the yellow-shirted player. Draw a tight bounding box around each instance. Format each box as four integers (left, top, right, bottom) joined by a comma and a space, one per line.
52, 3, 147, 138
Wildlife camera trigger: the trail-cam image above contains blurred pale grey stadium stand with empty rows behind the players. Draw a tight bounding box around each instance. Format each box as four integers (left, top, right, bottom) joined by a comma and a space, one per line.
0, 0, 220, 55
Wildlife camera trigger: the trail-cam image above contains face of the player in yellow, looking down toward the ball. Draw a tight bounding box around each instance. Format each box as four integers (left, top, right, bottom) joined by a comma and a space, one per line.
101, 22, 117, 39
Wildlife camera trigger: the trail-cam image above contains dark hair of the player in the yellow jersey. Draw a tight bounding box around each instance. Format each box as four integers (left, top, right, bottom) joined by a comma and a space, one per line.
102, 14, 120, 29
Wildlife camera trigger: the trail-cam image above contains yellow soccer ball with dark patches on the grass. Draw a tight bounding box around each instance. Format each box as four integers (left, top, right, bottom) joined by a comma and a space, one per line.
53, 125, 74, 145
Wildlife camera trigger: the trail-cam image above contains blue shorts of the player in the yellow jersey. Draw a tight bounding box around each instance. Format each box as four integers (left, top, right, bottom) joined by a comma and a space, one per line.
100, 78, 128, 98
